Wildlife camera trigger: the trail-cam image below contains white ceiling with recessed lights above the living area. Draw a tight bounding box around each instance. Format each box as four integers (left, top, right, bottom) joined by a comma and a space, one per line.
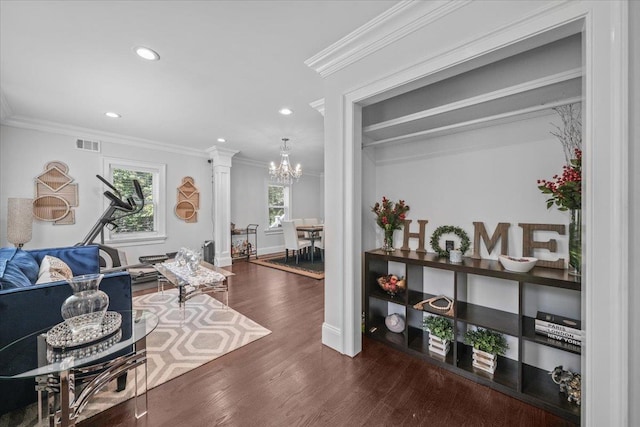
0, 0, 397, 172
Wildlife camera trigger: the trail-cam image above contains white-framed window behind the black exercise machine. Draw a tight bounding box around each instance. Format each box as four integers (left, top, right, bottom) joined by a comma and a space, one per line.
104, 158, 166, 243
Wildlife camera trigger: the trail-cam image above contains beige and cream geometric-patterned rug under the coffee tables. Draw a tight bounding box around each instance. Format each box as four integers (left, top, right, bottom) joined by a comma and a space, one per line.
0, 289, 271, 427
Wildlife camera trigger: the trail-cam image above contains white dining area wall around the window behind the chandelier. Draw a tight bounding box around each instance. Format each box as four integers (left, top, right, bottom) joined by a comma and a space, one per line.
231, 157, 324, 255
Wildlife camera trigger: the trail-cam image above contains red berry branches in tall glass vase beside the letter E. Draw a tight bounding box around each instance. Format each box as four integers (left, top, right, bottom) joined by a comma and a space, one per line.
538, 148, 582, 211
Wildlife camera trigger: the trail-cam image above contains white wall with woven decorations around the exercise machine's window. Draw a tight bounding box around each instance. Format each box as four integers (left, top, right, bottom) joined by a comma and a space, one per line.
0, 126, 213, 262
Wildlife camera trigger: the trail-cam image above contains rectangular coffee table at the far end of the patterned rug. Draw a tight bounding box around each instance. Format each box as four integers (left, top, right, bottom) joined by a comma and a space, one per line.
153, 260, 235, 307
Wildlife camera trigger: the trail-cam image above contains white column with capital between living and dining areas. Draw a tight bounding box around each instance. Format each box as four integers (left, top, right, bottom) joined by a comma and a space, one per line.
207, 147, 238, 267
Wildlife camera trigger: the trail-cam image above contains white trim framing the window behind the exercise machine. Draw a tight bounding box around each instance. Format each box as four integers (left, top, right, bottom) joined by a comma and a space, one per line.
102, 157, 167, 246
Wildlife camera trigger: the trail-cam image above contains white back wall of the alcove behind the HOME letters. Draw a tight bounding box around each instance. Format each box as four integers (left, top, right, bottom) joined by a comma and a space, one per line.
363, 111, 581, 372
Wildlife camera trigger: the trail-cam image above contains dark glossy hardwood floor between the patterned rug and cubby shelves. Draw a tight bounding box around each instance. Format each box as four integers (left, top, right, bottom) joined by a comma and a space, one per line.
79, 262, 571, 427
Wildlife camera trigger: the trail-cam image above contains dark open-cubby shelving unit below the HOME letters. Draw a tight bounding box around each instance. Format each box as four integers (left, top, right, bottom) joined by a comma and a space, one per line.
363, 250, 581, 424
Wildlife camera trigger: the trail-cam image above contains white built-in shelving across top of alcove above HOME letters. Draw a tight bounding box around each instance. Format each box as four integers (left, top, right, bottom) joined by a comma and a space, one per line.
362, 35, 583, 147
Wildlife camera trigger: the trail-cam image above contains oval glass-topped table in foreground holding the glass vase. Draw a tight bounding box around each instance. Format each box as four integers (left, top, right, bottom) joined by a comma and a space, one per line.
0, 310, 158, 427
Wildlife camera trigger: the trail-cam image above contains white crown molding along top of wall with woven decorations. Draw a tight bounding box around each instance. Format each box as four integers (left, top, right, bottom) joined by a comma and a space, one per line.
0, 116, 208, 158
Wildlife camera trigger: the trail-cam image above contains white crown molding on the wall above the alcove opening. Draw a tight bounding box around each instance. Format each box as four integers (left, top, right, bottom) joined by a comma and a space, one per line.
304, 0, 472, 77
